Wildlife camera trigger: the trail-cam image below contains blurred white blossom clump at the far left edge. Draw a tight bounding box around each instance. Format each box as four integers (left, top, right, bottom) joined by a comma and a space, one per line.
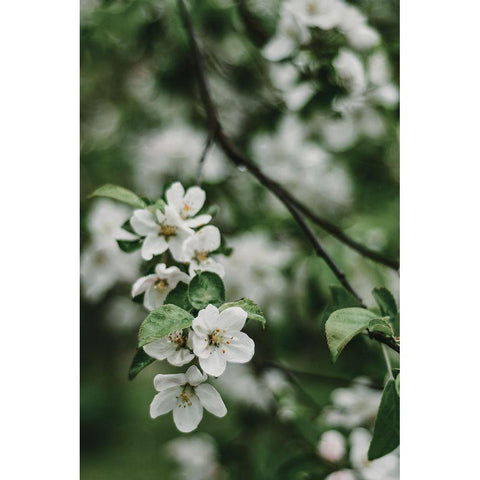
80, 199, 140, 302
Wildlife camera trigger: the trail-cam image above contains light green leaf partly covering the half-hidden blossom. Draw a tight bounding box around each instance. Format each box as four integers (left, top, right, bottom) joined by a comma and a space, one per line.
138, 305, 193, 348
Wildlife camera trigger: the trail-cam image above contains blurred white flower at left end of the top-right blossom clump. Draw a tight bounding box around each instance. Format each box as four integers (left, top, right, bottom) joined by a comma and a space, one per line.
262, 8, 309, 62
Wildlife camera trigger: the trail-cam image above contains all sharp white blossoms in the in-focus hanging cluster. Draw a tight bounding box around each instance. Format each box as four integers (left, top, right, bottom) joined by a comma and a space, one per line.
126, 182, 255, 432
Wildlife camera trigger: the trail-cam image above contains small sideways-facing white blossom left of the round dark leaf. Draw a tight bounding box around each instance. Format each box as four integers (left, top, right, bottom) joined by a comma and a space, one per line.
132, 263, 190, 310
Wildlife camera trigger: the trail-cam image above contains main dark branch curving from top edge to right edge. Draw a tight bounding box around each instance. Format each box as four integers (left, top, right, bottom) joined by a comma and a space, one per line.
178, 0, 399, 270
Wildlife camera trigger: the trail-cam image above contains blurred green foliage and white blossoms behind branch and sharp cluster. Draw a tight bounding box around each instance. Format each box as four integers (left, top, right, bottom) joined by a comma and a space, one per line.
80, 0, 399, 480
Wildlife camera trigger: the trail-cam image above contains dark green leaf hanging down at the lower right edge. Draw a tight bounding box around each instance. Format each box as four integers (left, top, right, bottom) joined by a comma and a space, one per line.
368, 377, 400, 460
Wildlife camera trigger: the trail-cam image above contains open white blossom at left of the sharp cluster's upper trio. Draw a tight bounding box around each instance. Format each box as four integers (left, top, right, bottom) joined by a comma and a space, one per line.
130, 205, 193, 262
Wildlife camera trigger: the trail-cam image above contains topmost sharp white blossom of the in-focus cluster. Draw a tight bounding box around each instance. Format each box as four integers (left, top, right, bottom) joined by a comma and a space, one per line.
166, 182, 212, 228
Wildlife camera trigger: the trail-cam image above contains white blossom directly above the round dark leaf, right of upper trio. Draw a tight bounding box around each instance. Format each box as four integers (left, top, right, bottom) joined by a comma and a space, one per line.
183, 225, 225, 277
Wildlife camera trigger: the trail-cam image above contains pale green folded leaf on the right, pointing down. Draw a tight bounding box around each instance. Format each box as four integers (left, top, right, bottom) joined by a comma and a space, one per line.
325, 307, 377, 362
